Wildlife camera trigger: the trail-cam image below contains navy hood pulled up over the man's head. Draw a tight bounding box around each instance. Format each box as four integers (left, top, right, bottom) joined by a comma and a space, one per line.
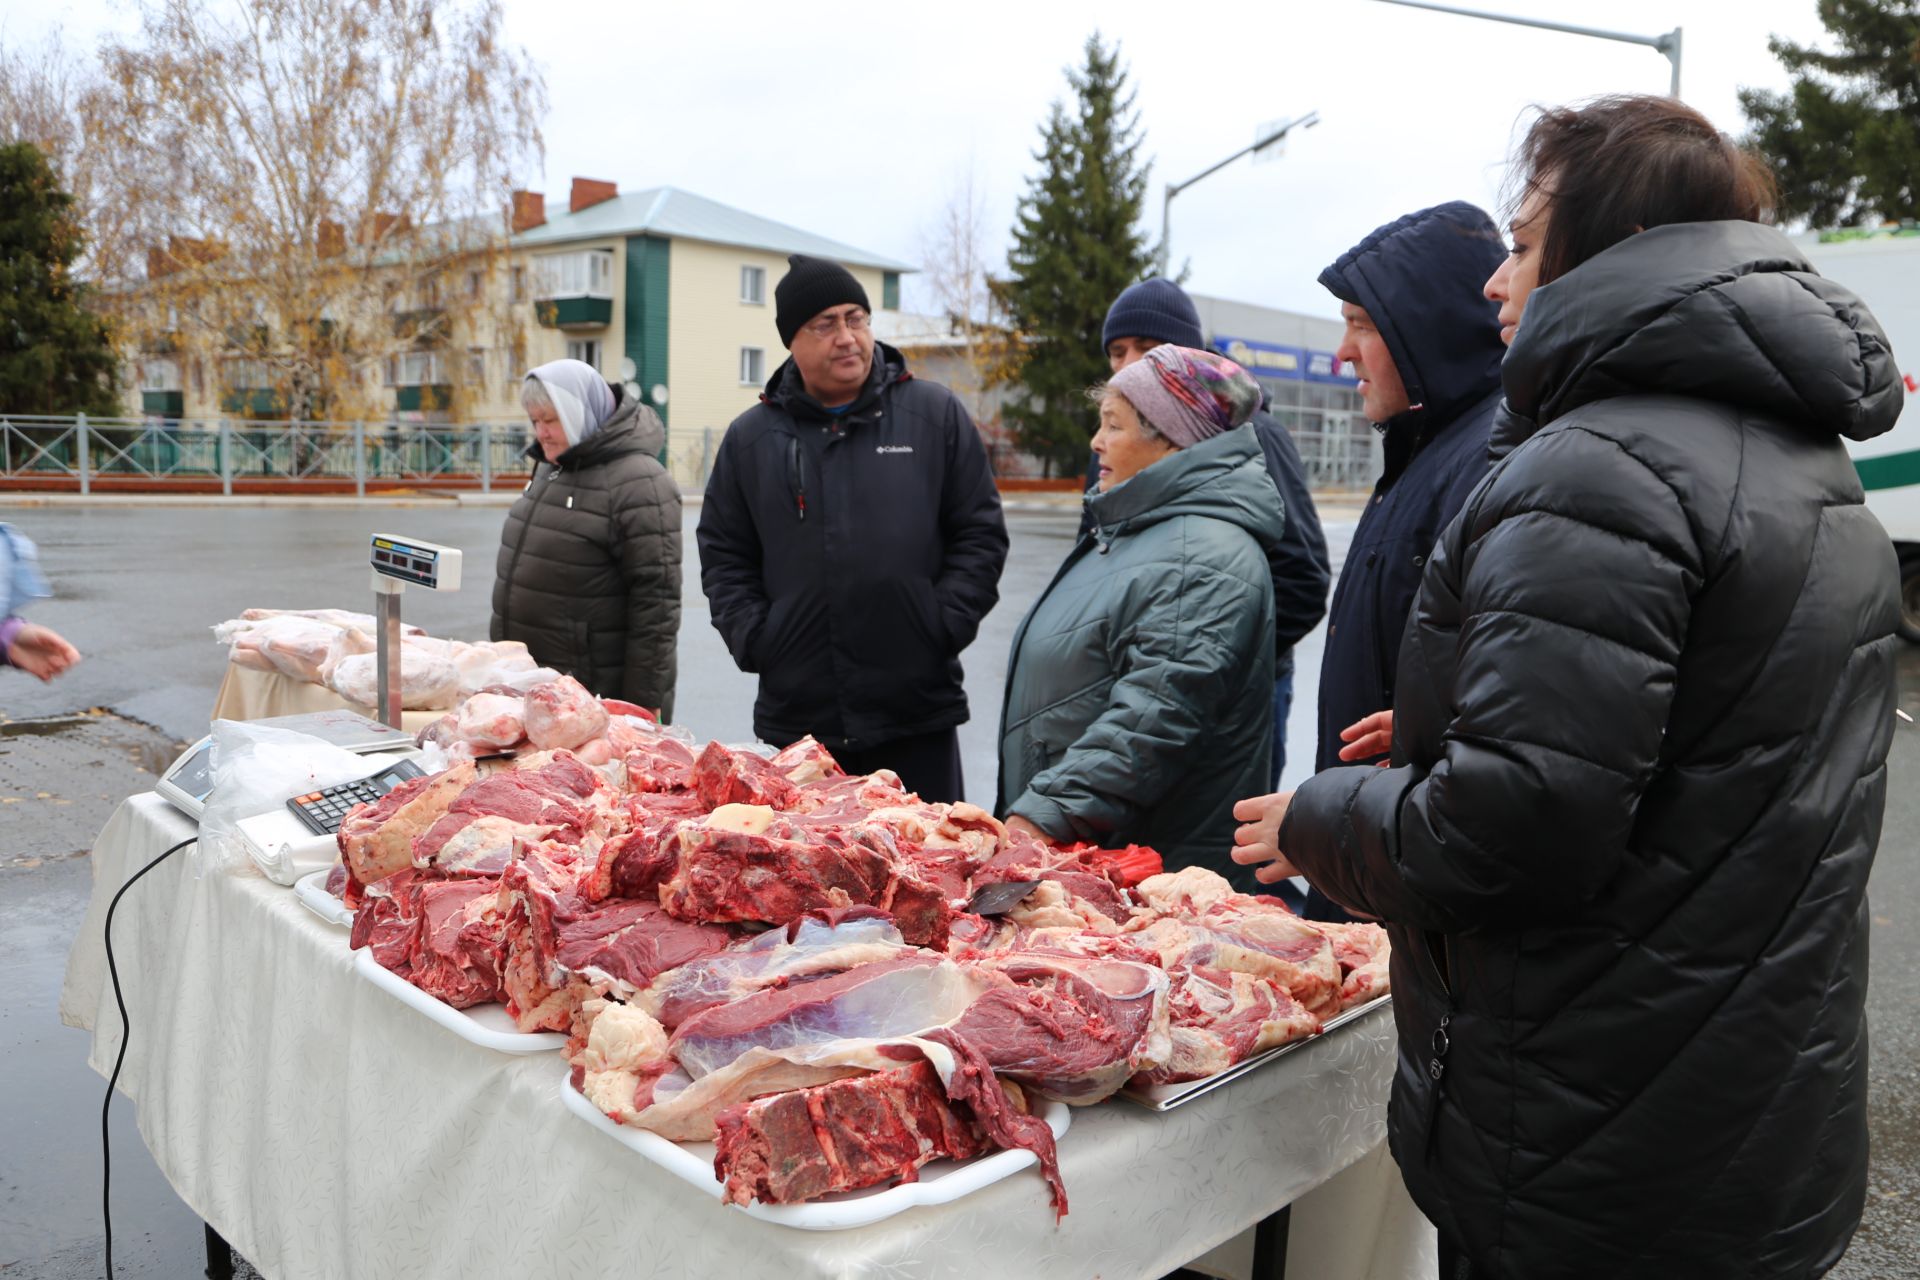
1319, 200, 1507, 424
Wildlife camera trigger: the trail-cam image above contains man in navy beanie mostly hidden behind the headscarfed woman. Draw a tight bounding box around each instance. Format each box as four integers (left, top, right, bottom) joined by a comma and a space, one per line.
1081, 276, 1331, 787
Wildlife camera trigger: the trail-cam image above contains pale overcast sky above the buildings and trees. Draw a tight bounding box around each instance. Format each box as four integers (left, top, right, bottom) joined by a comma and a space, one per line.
11, 0, 1822, 313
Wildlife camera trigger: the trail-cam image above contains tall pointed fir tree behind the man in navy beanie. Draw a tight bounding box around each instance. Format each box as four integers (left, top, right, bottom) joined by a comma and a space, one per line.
995, 33, 1152, 476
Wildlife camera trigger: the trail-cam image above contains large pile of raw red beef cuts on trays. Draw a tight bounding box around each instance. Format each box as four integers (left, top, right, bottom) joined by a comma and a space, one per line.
322, 681, 1388, 1213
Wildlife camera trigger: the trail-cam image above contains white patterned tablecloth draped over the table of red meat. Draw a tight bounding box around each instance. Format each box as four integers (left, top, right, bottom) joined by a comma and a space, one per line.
60, 794, 1434, 1280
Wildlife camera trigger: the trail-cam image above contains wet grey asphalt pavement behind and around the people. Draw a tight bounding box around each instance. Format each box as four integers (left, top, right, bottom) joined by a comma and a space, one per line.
0, 499, 1920, 1280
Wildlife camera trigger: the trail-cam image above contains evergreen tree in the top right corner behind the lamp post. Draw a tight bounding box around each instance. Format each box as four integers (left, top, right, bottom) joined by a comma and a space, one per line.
1740, 0, 1920, 226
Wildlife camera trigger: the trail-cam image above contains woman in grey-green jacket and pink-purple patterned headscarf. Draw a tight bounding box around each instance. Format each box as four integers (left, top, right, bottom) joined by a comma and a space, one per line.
996, 345, 1284, 890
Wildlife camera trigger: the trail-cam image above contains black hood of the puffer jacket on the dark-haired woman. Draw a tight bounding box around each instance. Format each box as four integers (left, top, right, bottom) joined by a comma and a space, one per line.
1494, 223, 1907, 457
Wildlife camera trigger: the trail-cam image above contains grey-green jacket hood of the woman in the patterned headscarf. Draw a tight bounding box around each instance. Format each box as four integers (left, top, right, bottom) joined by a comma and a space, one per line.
1087, 424, 1286, 558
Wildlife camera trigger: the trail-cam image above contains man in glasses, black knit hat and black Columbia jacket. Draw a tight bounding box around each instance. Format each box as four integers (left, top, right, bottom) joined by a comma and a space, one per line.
697, 253, 1006, 800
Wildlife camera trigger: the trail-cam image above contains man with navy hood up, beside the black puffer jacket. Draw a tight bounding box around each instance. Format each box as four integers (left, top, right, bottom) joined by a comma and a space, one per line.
1306, 200, 1507, 919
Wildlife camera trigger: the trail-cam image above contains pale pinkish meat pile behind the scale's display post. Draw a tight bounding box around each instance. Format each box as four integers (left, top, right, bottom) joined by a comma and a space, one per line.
213, 608, 559, 710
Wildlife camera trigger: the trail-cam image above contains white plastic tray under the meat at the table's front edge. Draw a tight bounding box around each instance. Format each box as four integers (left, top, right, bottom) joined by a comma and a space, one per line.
561, 1077, 1073, 1232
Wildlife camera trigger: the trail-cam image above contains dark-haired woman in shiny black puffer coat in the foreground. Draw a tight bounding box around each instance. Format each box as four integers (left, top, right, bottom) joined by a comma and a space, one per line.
1236, 98, 1901, 1280
